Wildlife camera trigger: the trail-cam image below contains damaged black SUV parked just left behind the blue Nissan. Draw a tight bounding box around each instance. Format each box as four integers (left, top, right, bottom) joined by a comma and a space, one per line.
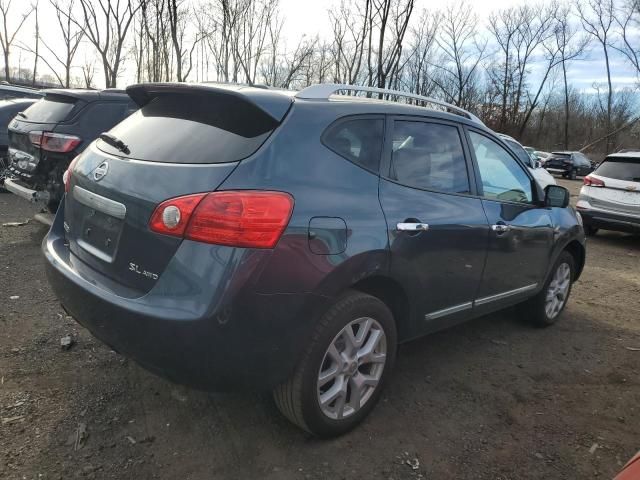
5, 89, 136, 212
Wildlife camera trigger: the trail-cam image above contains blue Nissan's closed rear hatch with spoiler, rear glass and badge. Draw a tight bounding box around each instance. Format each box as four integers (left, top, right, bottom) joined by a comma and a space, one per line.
64, 84, 292, 293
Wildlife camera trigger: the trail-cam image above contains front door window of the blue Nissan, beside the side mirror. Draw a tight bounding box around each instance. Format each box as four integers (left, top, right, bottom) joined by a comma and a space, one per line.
469, 132, 533, 202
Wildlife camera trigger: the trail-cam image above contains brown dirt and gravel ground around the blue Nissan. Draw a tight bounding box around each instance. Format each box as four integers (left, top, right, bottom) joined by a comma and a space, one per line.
0, 177, 640, 480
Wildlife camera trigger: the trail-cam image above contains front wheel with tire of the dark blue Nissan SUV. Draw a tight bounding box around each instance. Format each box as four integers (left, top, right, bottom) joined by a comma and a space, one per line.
522, 251, 575, 327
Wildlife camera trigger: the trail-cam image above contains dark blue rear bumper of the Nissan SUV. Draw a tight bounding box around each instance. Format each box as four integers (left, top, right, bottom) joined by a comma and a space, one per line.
43, 204, 327, 391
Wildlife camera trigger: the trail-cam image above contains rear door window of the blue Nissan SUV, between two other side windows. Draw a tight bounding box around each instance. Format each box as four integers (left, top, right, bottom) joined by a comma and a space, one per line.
390, 122, 470, 193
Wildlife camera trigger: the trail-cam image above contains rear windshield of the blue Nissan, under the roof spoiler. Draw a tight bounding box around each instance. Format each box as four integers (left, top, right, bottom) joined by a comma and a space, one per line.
98, 94, 278, 163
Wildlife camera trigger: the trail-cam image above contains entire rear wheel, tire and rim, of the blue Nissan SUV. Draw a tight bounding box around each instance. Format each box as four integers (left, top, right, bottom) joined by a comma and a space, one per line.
274, 291, 397, 437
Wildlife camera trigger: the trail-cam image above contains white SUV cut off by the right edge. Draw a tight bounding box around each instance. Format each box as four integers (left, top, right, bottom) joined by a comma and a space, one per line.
576, 152, 640, 235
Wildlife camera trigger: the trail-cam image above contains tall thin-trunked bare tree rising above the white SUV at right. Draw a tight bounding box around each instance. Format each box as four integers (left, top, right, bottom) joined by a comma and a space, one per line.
575, 0, 615, 153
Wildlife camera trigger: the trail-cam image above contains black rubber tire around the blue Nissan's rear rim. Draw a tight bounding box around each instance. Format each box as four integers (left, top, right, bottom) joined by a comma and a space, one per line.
273, 291, 397, 438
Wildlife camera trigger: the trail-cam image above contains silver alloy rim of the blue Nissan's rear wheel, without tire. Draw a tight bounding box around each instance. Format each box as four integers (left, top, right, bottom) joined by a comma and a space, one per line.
317, 317, 387, 420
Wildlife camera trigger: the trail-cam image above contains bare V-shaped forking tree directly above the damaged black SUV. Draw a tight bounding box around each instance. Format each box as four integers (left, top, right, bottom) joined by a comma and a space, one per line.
74, 0, 144, 88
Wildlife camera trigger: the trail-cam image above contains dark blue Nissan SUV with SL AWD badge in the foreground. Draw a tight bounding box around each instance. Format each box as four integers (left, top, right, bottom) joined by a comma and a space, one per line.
43, 84, 585, 436
